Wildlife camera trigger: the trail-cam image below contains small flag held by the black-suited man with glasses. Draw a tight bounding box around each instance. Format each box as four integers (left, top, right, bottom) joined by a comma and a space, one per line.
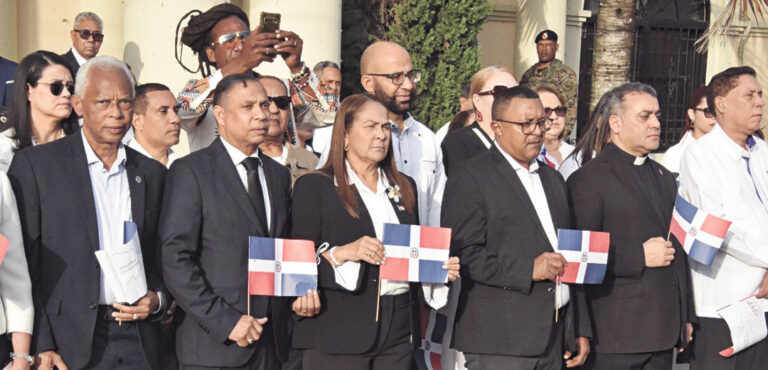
556, 229, 611, 284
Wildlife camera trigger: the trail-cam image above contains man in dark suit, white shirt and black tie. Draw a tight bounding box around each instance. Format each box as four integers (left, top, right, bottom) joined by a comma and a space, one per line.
160, 74, 310, 370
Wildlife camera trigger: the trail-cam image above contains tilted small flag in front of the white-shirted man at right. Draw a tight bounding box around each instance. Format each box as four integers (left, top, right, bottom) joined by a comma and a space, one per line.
669, 194, 731, 266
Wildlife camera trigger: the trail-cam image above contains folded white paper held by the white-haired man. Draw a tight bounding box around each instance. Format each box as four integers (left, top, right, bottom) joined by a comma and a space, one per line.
95, 221, 147, 304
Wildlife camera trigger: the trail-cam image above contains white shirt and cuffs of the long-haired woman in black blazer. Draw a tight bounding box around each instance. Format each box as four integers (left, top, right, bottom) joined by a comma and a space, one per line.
334, 161, 448, 309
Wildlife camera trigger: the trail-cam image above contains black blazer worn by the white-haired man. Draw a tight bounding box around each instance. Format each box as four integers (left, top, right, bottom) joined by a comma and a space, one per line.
8, 131, 166, 369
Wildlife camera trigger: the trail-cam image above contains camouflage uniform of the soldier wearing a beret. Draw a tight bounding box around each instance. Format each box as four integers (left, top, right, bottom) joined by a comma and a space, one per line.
520, 59, 579, 141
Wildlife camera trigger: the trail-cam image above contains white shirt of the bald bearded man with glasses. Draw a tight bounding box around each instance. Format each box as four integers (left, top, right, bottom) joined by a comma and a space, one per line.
392, 115, 446, 226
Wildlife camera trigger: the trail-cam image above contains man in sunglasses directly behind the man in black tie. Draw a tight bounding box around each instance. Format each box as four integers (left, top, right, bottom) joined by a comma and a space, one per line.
259, 76, 317, 185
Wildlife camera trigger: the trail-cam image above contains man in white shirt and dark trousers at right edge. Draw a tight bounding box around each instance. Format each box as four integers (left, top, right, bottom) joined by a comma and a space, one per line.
680, 67, 768, 370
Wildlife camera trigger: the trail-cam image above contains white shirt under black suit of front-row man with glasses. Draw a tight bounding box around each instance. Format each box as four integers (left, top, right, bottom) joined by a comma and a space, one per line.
493, 141, 571, 308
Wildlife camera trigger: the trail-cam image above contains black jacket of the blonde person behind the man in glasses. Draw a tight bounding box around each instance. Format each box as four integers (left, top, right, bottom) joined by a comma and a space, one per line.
440, 121, 493, 176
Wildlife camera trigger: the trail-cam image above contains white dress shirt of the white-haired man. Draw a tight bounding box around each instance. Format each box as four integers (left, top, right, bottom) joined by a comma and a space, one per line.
81, 133, 133, 305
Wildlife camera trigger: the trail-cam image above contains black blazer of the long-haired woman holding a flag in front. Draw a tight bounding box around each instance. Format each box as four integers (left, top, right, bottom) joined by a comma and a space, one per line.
291, 172, 421, 354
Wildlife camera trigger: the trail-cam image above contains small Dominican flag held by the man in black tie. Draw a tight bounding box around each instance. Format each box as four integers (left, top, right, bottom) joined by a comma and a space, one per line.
248, 236, 317, 297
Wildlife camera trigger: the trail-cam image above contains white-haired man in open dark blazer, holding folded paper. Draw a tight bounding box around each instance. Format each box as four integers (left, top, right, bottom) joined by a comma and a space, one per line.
8, 57, 167, 369
